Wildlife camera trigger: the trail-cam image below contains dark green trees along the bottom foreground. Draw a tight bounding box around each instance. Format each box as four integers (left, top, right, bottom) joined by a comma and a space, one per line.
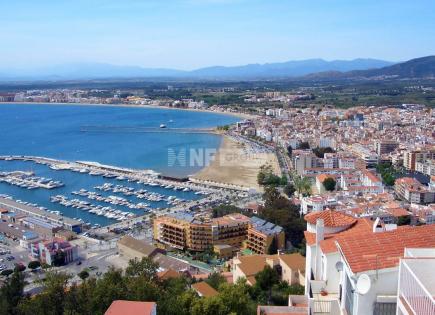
0, 258, 304, 315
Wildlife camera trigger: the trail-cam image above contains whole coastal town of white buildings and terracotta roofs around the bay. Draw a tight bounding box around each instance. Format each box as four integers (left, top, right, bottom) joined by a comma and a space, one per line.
0, 86, 435, 314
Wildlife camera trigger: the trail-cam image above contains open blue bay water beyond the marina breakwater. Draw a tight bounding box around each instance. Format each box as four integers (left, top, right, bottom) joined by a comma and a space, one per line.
0, 104, 238, 176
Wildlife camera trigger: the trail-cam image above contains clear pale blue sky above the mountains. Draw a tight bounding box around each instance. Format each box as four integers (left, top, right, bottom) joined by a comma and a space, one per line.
0, 0, 435, 69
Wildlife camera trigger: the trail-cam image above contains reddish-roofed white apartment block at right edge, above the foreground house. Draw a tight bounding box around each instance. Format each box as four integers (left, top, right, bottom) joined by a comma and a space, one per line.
394, 177, 435, 204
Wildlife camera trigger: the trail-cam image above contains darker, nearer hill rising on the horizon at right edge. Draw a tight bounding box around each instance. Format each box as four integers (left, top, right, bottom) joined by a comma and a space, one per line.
305, 56, 435, 79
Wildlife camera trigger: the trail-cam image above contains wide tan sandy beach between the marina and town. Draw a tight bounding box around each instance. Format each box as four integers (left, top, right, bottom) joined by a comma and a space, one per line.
192, 136, 280, 191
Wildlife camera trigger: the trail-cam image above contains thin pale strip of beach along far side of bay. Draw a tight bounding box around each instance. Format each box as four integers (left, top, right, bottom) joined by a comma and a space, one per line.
0, 102, 255, 120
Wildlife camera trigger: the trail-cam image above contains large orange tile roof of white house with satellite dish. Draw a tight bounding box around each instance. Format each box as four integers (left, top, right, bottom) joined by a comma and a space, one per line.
337, 225, 435, 273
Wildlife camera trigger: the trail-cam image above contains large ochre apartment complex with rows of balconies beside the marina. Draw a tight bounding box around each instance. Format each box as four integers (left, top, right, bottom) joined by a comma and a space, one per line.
154, 212, 285, 254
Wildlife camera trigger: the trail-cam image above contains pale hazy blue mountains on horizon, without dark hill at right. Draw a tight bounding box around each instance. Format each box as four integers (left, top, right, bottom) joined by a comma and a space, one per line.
0, 59, 393, 80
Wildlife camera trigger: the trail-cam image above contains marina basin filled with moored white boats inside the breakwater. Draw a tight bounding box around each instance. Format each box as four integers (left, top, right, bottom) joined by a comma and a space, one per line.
0, 156, 240, 228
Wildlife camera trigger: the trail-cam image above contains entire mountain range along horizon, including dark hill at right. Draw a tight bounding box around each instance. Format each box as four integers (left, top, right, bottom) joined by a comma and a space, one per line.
0, 56, 435, 81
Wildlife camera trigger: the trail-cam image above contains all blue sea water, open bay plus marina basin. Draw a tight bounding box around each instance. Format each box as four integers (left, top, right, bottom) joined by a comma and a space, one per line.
0, 103, 240, 226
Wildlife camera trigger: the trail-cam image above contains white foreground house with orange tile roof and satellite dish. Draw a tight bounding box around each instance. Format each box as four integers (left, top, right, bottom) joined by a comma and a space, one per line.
336, 225, 435, 315
